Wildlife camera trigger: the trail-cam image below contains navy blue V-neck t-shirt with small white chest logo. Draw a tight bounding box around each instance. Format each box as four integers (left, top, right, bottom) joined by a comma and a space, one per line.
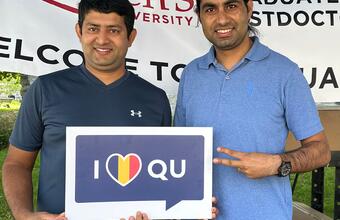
10, 65, 171, 213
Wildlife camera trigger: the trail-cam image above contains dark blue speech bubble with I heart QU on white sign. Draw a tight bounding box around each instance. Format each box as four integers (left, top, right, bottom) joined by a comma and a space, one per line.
75, 135, 204, 210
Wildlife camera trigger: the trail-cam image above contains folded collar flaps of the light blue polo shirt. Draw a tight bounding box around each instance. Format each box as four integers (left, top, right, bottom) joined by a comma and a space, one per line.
199, 37, 270, 69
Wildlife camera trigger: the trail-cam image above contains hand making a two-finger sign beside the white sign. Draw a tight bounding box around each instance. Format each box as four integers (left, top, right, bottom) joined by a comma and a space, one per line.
213, 147, 282, 179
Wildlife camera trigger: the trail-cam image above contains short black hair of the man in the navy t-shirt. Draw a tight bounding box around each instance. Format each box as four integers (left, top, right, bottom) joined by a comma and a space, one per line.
78, 0, 135, 36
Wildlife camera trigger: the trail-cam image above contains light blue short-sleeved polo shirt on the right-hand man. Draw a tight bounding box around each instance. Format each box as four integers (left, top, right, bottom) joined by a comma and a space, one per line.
174, 37, 323, 220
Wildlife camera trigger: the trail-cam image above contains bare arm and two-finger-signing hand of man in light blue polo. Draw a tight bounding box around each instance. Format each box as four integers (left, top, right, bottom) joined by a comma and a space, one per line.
213, 132, 331, 178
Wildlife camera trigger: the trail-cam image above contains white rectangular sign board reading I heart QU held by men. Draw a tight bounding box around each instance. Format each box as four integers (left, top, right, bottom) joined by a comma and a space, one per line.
65, 127, 212, 220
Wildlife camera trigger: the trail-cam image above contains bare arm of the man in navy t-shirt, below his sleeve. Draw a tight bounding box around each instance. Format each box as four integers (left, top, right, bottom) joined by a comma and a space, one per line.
2, 145, 65, 220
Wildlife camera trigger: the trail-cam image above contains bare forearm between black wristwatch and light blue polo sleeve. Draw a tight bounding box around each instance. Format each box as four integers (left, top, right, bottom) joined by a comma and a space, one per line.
280, 140, 331, 173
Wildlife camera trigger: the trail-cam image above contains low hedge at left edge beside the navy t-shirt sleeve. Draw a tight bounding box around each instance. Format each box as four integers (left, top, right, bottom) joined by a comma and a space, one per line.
0, 110, 18, 150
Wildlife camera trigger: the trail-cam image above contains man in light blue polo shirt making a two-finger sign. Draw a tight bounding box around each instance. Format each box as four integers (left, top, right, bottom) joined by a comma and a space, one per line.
174, 0, 330, 220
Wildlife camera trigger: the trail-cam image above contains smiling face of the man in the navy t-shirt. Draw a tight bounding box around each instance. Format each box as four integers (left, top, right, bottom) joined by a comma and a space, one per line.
76, 11, 136, 74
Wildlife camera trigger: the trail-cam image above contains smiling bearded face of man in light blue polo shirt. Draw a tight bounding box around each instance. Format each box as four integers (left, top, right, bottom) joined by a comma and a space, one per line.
199, 0, 253, 50
